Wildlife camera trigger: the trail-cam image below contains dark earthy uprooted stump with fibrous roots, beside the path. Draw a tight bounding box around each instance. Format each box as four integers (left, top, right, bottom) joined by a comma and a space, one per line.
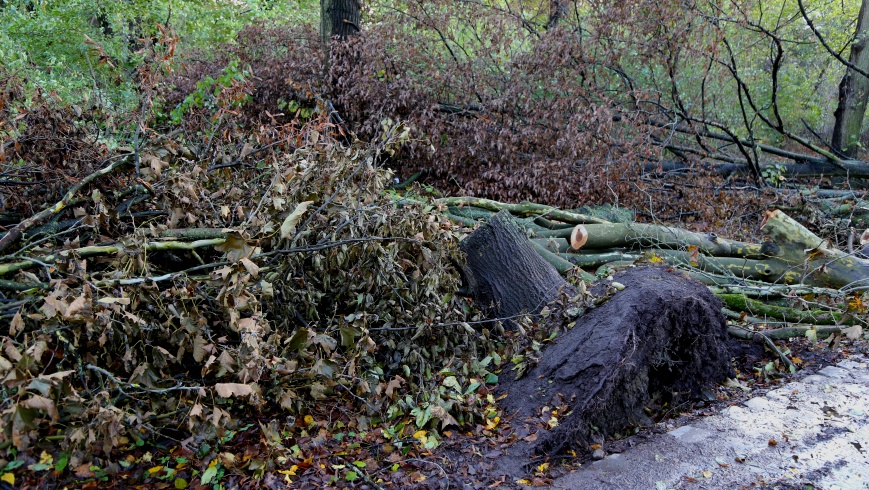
498, 267, 733, 460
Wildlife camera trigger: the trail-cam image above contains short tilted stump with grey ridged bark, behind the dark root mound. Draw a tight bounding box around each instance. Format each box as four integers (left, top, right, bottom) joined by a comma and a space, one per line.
459, 211, 573, 318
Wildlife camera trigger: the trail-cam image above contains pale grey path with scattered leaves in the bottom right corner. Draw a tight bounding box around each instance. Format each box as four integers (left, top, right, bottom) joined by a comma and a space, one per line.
552, 355, 869, 490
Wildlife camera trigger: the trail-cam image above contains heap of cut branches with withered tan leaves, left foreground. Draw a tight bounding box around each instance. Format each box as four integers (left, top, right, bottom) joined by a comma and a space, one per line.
0, 120, 496, 464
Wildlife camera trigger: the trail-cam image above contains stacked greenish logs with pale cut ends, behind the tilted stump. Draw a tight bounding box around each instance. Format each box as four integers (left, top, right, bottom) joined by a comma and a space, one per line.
438, 197, 869, 352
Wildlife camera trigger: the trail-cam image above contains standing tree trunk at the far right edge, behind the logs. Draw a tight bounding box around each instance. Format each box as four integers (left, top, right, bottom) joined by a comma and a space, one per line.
832, 0, 869, 157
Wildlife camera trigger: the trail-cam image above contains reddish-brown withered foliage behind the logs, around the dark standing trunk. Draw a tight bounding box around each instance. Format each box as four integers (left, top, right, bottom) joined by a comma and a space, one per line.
153, 15, 782, 232
